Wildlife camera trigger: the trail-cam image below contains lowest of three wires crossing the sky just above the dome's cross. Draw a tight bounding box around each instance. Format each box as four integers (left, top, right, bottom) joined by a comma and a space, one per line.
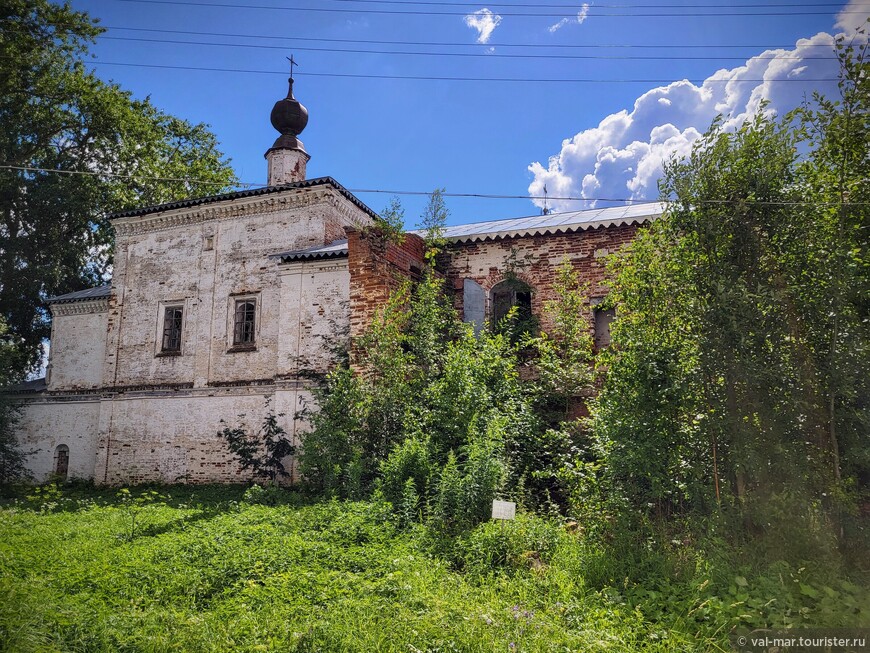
90, 59, 837, 84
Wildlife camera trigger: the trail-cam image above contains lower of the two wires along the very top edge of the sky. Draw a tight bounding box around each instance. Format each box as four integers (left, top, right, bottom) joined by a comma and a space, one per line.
110, 0, 864, 18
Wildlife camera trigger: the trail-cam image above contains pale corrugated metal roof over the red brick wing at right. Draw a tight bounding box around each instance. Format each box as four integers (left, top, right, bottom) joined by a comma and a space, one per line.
430, 202, 665, 242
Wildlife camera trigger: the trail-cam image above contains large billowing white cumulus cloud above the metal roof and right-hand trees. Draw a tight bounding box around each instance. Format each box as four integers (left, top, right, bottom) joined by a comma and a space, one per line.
528, 22, 862, 211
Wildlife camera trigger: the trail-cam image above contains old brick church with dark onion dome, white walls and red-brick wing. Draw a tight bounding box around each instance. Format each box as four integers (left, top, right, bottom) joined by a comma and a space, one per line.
10, 79, 662, 485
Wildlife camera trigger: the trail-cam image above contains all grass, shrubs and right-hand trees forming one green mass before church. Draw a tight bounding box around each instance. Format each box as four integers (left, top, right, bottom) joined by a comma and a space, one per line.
0, 16, 870, 651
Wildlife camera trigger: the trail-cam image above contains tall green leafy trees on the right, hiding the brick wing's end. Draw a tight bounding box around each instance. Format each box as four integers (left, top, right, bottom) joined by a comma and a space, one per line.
594, 40, 870, 523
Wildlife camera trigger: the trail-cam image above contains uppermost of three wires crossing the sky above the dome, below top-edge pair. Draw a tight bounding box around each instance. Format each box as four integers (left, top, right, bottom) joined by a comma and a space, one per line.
102, 25, 832, 50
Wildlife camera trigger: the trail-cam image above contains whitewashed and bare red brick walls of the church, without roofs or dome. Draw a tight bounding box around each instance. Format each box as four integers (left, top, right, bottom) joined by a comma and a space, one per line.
20, 173, 652, 484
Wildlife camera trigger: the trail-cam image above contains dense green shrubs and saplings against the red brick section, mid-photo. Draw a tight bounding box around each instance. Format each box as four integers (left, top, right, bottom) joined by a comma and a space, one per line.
300, 192, 608, 529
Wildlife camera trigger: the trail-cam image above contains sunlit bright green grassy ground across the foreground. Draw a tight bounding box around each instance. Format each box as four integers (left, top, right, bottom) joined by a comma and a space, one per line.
0, 487, 870, 653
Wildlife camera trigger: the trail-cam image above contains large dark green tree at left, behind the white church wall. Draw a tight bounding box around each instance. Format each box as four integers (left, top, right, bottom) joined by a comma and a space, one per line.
0, 0, 236, 368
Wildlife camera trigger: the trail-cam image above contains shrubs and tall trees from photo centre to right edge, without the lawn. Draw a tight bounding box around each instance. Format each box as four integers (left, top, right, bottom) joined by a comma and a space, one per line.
284, 43, 870, 648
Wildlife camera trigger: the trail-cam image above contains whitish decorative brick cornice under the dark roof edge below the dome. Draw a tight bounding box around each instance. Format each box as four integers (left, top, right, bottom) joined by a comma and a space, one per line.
112, 186, 368, 237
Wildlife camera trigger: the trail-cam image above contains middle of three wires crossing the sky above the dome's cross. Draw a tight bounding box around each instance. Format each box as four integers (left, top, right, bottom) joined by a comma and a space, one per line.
100, 36, 837, 61
